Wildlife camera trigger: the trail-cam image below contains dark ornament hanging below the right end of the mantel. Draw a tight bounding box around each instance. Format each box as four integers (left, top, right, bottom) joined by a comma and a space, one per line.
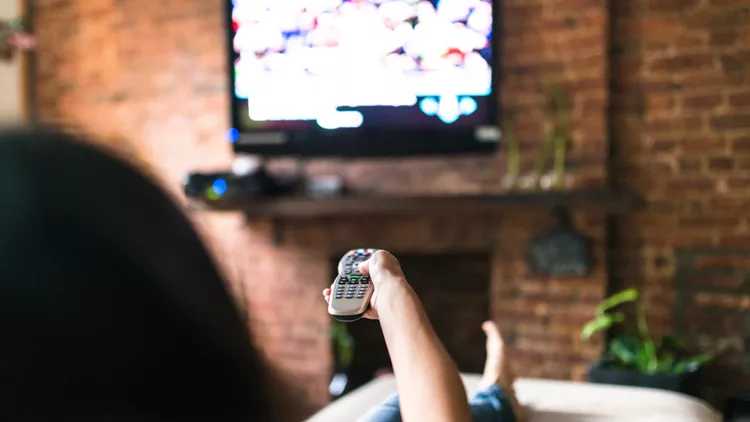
529, 210, 593, 277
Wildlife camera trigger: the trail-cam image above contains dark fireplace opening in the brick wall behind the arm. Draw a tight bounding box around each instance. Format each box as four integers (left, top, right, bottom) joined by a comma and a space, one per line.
332, 253, 491, 393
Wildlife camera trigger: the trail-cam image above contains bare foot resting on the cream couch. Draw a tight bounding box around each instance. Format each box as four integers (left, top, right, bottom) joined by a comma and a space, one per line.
479, 321, 524, 422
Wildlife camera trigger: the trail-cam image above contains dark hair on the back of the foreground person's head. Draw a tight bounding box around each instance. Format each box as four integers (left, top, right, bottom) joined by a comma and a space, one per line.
0, 130, 270, 421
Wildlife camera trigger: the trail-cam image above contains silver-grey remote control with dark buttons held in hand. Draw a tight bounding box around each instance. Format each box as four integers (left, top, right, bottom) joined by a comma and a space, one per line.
328, 249, 377, 322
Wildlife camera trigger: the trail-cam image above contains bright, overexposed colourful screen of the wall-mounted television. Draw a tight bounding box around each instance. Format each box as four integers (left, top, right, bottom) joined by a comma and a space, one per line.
231, 0, 494, 132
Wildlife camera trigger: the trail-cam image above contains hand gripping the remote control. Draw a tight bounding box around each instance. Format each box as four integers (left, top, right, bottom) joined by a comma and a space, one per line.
323, 250, 406, 319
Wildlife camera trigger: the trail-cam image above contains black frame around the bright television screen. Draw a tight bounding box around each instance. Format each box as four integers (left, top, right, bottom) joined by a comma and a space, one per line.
224, 0, 502, 157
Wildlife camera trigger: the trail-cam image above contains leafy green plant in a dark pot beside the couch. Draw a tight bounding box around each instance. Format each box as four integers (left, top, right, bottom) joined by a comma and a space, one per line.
581, 288, 714, 395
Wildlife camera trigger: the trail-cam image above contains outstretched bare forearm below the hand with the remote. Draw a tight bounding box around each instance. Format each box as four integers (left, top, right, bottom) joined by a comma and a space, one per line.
377, 274, 471, 422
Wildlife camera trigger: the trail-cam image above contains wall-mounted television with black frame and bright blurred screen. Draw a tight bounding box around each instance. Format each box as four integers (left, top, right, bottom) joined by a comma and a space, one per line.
226, 0, 501, 157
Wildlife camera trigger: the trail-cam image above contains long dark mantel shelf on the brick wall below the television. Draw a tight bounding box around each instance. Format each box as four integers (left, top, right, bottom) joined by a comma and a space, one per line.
189, 189, 643, 219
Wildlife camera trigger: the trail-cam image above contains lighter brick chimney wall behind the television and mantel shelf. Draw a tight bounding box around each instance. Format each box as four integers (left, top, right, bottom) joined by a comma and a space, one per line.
35, 0, 612, 420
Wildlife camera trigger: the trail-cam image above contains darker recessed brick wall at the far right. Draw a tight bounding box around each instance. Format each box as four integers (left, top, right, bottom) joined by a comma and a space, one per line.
611, 0, 750, 404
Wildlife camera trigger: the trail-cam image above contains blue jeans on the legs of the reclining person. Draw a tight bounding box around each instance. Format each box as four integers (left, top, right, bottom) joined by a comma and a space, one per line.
361, 385, 516, 422
